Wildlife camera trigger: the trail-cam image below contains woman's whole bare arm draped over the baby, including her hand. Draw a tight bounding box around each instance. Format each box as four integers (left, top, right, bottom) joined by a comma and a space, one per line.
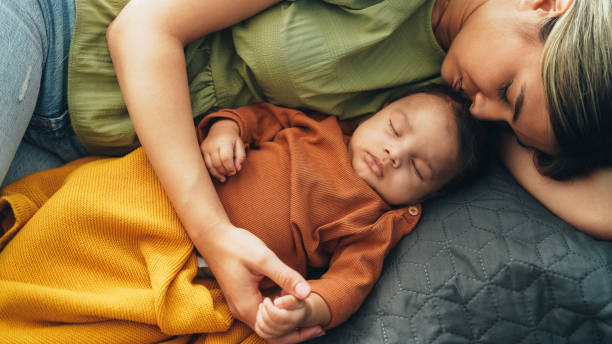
107, 0, 310, 339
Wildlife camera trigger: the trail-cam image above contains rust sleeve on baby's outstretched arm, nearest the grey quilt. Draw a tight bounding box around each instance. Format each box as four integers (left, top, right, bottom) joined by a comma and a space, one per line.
309, 205, 421, 329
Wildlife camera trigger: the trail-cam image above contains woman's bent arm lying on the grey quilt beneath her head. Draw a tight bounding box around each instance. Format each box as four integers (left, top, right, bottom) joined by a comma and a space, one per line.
502, 134, 612, 239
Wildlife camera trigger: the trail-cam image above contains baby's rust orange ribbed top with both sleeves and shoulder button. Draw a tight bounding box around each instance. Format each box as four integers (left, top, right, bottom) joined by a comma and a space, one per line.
198, 103, 421, 328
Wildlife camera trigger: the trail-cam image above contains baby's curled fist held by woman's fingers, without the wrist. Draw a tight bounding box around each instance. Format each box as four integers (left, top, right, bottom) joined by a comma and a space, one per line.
255, 295, 308, 339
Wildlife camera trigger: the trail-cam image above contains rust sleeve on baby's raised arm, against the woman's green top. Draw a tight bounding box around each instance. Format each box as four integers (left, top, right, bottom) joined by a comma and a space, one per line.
197, 103, 306, 145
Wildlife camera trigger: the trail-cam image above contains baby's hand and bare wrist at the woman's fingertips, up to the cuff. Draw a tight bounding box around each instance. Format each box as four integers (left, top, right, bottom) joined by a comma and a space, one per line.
255, 293, 331, 339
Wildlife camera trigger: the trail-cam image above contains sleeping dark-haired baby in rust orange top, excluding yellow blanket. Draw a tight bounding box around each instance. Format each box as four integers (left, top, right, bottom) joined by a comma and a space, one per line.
198, 86, 485, 338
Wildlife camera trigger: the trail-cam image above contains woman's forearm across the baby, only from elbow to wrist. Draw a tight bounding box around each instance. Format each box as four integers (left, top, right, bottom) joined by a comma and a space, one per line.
109, 18, 229, 246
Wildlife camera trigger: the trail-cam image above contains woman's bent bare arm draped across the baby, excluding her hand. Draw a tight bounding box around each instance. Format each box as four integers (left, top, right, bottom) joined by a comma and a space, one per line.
107, 0, 278, 246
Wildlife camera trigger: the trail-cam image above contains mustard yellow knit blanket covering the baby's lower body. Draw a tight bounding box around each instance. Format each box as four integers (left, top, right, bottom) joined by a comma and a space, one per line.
0, 150, 263, 343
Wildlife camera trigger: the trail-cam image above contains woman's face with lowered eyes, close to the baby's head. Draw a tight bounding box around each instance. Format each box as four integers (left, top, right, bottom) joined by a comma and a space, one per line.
442, 0, 556, 154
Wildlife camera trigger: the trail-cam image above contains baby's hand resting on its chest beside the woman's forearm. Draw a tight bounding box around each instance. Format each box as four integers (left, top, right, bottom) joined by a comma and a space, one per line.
200, 119, 246, 182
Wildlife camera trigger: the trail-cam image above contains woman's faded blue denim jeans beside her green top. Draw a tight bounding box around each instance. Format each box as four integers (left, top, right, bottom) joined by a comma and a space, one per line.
0, 0, 87, 185
